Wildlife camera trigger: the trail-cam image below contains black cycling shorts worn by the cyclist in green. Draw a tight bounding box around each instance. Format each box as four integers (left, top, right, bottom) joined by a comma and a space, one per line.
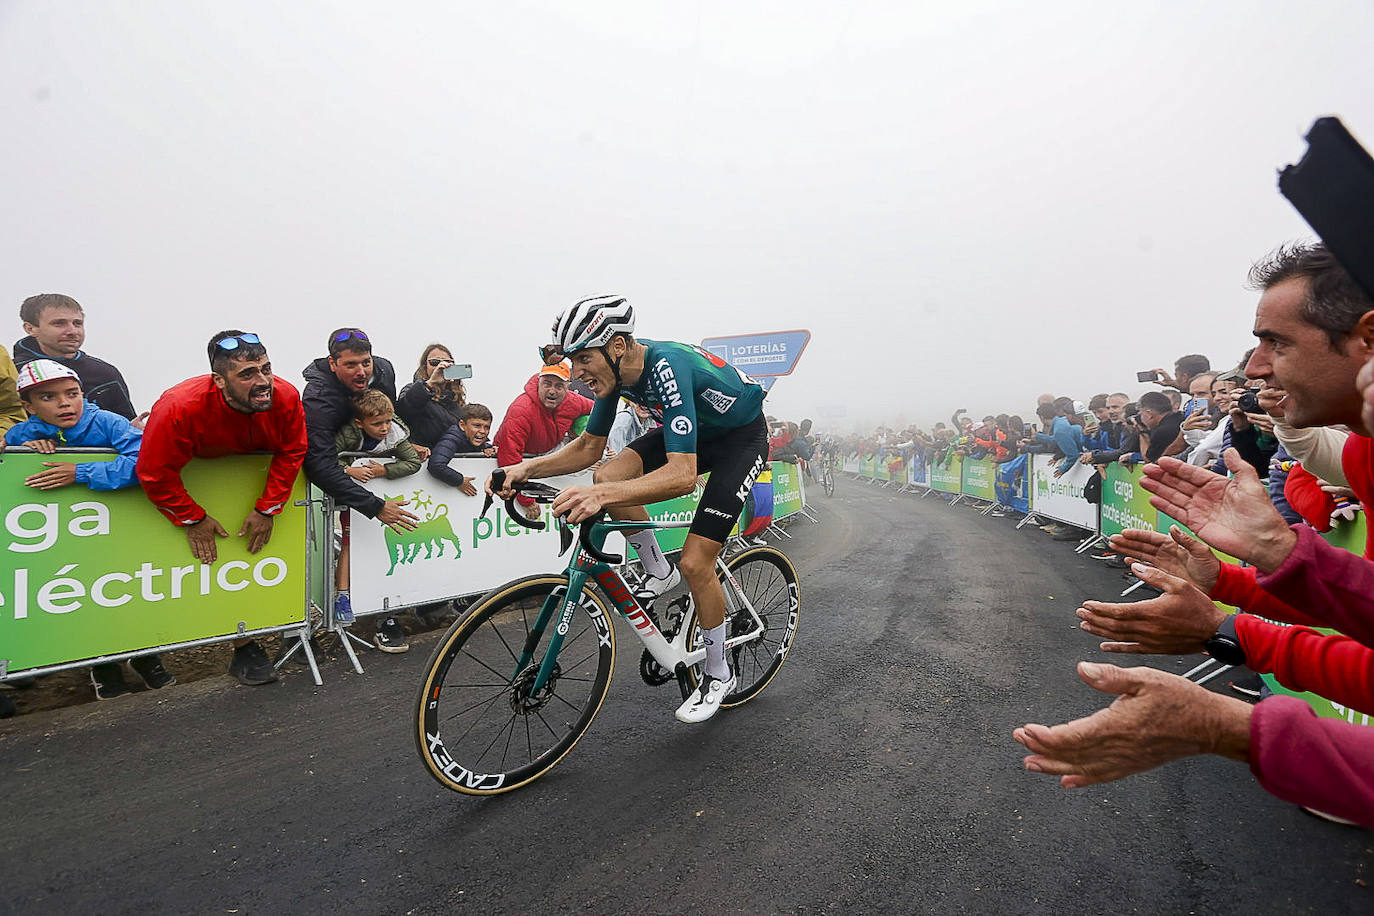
627, 413, 768, 544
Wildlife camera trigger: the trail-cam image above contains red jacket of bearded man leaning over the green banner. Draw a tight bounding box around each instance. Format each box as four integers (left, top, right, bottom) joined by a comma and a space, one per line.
139, 375, 305, 525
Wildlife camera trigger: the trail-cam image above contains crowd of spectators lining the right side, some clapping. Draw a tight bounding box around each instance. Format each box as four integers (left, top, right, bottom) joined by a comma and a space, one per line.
802, 243, 1374, 827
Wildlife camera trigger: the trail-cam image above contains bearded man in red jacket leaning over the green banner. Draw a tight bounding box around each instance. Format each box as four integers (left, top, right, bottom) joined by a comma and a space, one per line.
137, 330, 305, 685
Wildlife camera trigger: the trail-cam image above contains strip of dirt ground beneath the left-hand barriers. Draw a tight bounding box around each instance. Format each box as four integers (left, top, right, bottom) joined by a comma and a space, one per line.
0, 611, 461, 728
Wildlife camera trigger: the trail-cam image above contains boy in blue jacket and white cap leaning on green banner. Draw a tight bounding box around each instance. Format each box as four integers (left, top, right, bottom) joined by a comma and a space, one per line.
4, 360, 176, 700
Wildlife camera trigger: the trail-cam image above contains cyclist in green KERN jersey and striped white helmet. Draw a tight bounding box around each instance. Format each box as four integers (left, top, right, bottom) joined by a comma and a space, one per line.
486, 295, 768, 722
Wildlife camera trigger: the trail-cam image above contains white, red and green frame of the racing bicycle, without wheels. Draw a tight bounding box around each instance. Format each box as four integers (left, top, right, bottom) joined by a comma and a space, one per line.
513, 522, 764, 694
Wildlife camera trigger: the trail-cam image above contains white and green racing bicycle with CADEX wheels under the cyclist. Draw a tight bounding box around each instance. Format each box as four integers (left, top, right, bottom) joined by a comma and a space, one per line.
415, 471, 801, 795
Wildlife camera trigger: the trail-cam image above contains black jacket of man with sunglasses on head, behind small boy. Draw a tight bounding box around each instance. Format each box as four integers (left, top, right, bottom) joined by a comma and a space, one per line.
301, 356, 396, 518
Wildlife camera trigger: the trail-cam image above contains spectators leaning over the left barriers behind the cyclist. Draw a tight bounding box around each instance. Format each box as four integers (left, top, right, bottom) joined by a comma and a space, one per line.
0, 294, 665, 717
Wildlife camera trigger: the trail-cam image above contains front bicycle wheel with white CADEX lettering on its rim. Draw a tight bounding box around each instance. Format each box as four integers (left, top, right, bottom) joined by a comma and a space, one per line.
415, 574, 616, 795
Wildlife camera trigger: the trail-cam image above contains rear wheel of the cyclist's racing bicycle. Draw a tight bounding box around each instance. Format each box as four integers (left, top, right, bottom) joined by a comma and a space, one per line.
683, 547, 801, 707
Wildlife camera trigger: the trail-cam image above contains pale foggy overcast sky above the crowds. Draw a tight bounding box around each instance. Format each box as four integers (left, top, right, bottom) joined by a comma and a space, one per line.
0, 0, 1374, 431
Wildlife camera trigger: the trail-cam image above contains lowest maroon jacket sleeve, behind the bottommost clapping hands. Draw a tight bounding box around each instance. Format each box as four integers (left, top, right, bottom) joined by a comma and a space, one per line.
1250, 696, 1374, 827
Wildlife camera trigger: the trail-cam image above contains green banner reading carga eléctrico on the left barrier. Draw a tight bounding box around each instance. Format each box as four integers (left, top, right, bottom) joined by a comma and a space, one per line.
0, 452, 306, 672
